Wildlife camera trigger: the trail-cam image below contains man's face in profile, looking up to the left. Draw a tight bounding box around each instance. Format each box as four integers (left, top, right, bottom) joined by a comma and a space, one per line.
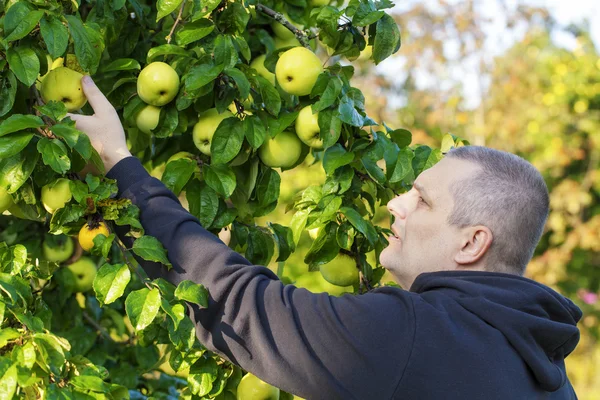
380, 158, 478, 290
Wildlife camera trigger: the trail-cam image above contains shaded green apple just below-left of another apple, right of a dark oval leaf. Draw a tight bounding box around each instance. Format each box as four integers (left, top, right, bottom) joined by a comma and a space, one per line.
258, 131, 302, 168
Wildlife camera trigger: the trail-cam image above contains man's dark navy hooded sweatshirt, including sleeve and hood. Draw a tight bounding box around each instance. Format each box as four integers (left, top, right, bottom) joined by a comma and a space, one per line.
108, 157, 581, 400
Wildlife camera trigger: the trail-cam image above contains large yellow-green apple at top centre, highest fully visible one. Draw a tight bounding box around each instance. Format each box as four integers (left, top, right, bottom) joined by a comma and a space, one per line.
275, 47, 323, 96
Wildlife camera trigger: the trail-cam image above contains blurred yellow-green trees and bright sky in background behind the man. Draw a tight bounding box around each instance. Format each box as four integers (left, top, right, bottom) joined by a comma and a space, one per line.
260, 0, 600, 400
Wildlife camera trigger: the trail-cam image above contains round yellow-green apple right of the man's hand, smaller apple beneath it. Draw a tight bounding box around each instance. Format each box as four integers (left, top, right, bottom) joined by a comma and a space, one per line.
137, 61, 179, 107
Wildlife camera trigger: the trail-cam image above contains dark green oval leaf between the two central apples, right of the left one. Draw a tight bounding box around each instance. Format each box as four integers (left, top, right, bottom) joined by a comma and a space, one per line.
210, 117, 244, 164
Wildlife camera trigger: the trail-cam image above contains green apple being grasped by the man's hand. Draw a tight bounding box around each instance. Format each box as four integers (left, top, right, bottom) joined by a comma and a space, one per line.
40, 67, 87, 112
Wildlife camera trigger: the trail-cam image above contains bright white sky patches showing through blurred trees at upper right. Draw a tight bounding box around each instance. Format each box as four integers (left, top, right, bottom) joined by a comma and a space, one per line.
377, 0, 600, 108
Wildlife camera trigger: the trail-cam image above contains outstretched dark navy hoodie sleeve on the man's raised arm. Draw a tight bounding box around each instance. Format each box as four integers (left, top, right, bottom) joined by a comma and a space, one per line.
107, 157, 415, 400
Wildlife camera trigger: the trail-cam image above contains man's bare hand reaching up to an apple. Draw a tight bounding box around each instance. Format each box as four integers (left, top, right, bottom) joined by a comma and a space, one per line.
67, 75, 131, 172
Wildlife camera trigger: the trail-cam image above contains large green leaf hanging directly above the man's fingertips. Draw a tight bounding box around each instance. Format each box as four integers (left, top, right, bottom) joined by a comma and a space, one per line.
65, 15, 104, 74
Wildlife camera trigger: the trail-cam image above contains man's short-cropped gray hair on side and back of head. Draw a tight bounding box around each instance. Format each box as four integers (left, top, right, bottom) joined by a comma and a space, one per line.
446, 146, 550, 275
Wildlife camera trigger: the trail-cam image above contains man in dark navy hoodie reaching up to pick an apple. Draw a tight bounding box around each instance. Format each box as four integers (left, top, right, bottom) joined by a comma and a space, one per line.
70, 77, 581, 400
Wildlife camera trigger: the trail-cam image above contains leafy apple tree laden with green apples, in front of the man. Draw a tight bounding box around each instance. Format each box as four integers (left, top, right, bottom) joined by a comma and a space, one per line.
0, 0, 464, 399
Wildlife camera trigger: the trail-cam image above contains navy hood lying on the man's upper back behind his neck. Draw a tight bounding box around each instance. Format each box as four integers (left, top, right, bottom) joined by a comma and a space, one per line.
410, 271, 582, 392
